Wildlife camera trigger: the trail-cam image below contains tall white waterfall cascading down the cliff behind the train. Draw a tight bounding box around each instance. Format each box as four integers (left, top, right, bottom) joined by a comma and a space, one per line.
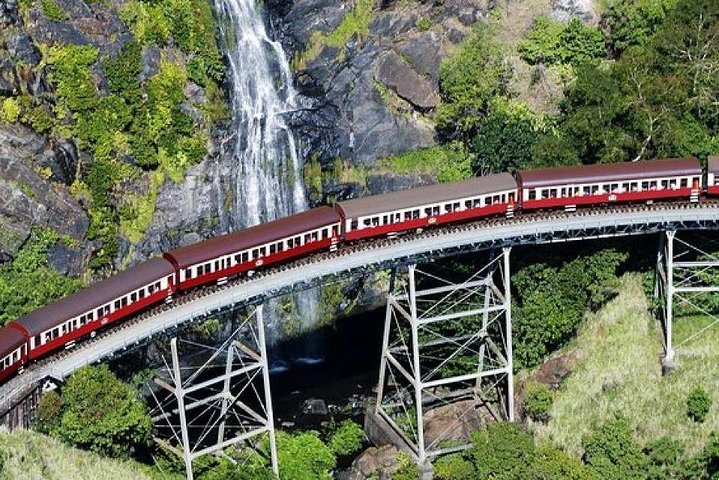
215, 0, 318, 348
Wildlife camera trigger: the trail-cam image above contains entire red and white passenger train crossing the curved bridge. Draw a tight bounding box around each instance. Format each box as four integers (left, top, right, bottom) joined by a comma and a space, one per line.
0, 156, 719, 382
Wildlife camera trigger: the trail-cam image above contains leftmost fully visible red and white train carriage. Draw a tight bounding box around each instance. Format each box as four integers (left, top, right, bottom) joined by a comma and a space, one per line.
8, 258, 175, 359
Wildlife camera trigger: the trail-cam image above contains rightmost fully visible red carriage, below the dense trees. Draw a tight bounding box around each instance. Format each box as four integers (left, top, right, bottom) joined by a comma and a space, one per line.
517, 158, 702, 210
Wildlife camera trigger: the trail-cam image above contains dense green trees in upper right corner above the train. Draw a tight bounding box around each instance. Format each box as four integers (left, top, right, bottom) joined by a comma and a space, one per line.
535, 0, 719, 164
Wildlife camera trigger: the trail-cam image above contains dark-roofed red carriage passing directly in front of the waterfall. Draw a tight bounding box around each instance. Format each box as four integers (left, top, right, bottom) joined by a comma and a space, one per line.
165, 207, 340, 290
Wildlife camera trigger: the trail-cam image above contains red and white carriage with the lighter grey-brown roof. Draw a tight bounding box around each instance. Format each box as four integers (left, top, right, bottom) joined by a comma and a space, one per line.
337, 173, 517, 240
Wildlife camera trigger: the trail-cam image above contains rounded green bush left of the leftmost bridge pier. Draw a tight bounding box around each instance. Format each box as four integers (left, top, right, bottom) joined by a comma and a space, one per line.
44, 365, 152, 457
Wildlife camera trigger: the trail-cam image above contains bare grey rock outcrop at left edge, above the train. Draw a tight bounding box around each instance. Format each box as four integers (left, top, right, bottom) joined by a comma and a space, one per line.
0, 124, 89, 258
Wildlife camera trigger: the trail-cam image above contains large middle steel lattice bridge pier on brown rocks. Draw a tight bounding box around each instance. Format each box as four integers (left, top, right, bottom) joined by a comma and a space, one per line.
371, 248, 514, 464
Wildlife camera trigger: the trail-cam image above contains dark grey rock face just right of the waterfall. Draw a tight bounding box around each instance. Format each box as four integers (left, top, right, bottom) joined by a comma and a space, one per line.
268, 0, 486, 172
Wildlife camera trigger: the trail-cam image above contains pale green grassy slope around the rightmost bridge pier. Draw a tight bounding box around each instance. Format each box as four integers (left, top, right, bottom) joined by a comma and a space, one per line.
534, 274, 719, 455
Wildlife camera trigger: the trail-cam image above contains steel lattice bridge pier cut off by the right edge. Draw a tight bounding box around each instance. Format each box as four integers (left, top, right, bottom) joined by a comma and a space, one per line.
654, 230, 719, 374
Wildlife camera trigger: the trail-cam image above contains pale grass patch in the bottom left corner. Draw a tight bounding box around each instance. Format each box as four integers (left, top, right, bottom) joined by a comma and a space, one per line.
0, 430, 170, 480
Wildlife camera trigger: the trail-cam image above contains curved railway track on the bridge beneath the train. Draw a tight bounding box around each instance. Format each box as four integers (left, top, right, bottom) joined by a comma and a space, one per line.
0, 199, 719, 417
